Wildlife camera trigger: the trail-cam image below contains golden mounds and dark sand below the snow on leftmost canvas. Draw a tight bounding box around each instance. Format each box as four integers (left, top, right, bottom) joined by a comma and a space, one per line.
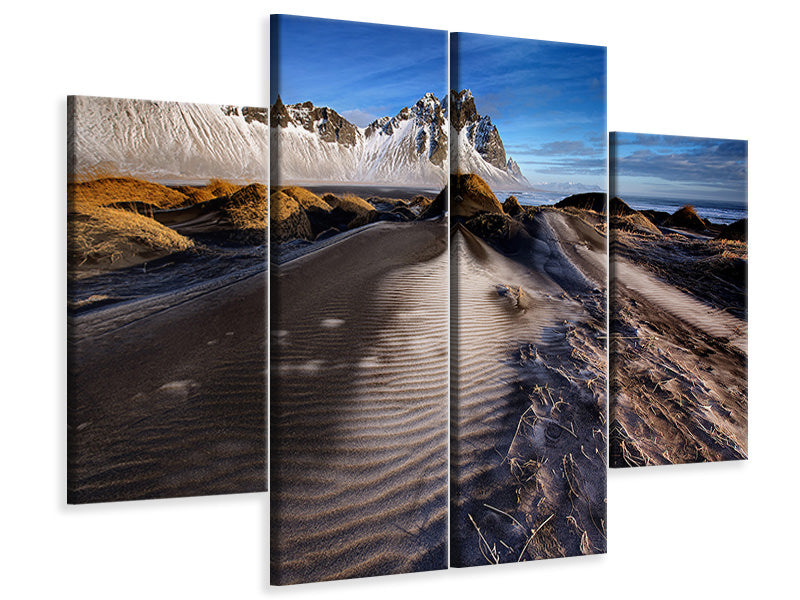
67, 177, 267, 503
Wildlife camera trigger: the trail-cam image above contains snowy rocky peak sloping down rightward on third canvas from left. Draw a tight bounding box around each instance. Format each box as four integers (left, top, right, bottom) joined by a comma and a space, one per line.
450, 90, 530, 190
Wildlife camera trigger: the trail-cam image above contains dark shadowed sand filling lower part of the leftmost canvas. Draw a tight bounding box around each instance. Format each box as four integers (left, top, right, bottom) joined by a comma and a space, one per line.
68, 270, 266, 503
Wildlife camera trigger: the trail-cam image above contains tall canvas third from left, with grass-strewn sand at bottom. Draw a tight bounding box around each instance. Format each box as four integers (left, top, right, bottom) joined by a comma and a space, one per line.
450, 33, 607, 567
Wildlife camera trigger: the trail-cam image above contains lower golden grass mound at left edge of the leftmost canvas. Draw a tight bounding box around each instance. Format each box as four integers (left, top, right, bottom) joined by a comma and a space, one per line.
67, 206, 194, 267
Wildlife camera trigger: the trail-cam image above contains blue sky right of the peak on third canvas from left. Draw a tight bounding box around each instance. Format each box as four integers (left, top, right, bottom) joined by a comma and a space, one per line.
451, 33, 606, 189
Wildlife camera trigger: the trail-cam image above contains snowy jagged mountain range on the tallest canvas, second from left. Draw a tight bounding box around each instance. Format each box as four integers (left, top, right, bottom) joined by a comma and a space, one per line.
270, 93, 447, 187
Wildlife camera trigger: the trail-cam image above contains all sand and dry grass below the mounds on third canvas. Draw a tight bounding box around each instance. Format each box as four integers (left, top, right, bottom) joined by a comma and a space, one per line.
451, 209, 606, 566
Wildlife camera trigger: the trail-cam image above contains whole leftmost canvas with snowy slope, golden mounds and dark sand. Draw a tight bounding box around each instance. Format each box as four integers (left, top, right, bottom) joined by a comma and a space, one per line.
67, 96, 269, 503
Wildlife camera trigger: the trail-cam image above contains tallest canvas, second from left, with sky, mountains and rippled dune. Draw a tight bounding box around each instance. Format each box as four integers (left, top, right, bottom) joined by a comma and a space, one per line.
270, 16, 448, 585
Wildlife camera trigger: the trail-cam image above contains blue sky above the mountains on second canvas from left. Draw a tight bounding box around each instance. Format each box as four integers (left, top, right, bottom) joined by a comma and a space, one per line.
270, 15, 447, 126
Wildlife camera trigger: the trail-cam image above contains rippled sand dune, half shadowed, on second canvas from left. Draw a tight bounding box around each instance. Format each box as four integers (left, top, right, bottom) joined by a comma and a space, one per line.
270, 221, 448, 585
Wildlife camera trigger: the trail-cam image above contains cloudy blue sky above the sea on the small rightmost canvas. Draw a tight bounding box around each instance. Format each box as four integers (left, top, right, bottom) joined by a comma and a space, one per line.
611, 132, 747, 203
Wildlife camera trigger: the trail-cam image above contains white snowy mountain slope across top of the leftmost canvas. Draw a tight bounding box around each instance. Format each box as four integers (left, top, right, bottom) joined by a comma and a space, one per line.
70, 96, 269, 181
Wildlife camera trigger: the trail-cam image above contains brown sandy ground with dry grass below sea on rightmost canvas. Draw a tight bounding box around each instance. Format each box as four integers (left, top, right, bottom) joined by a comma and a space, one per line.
610, 227, 747, 467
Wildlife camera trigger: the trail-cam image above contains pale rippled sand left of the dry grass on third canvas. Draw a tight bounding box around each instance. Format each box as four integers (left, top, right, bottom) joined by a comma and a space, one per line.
451, 231, 592, 566
